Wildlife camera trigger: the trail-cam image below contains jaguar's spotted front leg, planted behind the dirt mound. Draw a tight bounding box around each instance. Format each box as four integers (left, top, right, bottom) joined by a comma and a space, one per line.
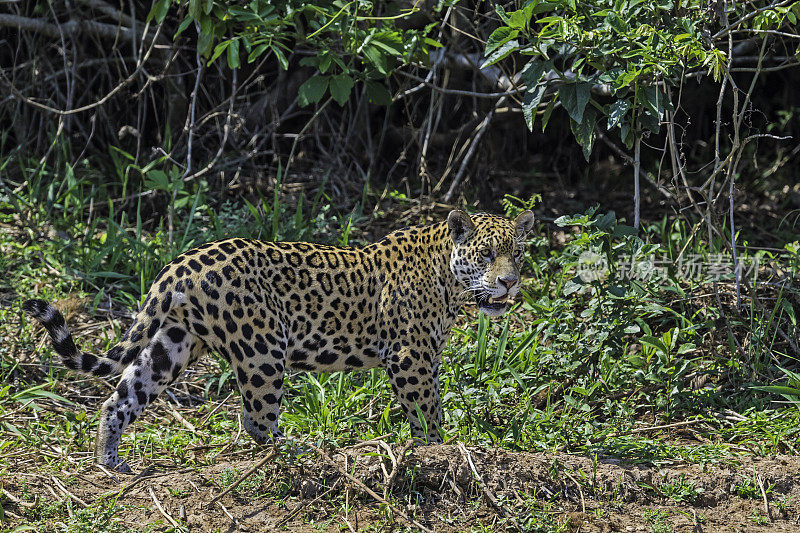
386, 346, 442, 443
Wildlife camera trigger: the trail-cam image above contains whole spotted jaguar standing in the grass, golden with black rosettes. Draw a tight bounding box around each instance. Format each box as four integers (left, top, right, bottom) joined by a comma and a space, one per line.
23, 210, 533, 470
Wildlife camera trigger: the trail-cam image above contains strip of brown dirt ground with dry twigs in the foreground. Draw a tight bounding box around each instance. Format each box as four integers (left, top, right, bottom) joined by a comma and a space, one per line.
3, 441, 800, 532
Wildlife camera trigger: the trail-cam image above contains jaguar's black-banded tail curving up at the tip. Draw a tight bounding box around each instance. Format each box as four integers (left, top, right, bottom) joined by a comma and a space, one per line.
22, 300, 127, 376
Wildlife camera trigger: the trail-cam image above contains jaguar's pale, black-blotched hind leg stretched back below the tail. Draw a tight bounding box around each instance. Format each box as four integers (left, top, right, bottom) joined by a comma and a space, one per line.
95, 323, 198, 472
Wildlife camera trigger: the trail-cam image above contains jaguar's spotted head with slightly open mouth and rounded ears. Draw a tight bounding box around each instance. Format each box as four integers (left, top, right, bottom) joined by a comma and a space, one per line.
447, 209, 533, 316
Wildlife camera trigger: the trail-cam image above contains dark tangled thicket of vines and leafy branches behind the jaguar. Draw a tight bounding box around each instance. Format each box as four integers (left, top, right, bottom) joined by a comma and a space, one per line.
0, 0, 800, 214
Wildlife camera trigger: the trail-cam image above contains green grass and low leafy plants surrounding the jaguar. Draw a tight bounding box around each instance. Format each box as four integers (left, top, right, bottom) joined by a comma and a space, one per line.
0, 153, 800, 531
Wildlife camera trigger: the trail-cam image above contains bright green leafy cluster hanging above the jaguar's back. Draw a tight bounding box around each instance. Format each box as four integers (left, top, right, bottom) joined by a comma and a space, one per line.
151, 0, 443, 106
